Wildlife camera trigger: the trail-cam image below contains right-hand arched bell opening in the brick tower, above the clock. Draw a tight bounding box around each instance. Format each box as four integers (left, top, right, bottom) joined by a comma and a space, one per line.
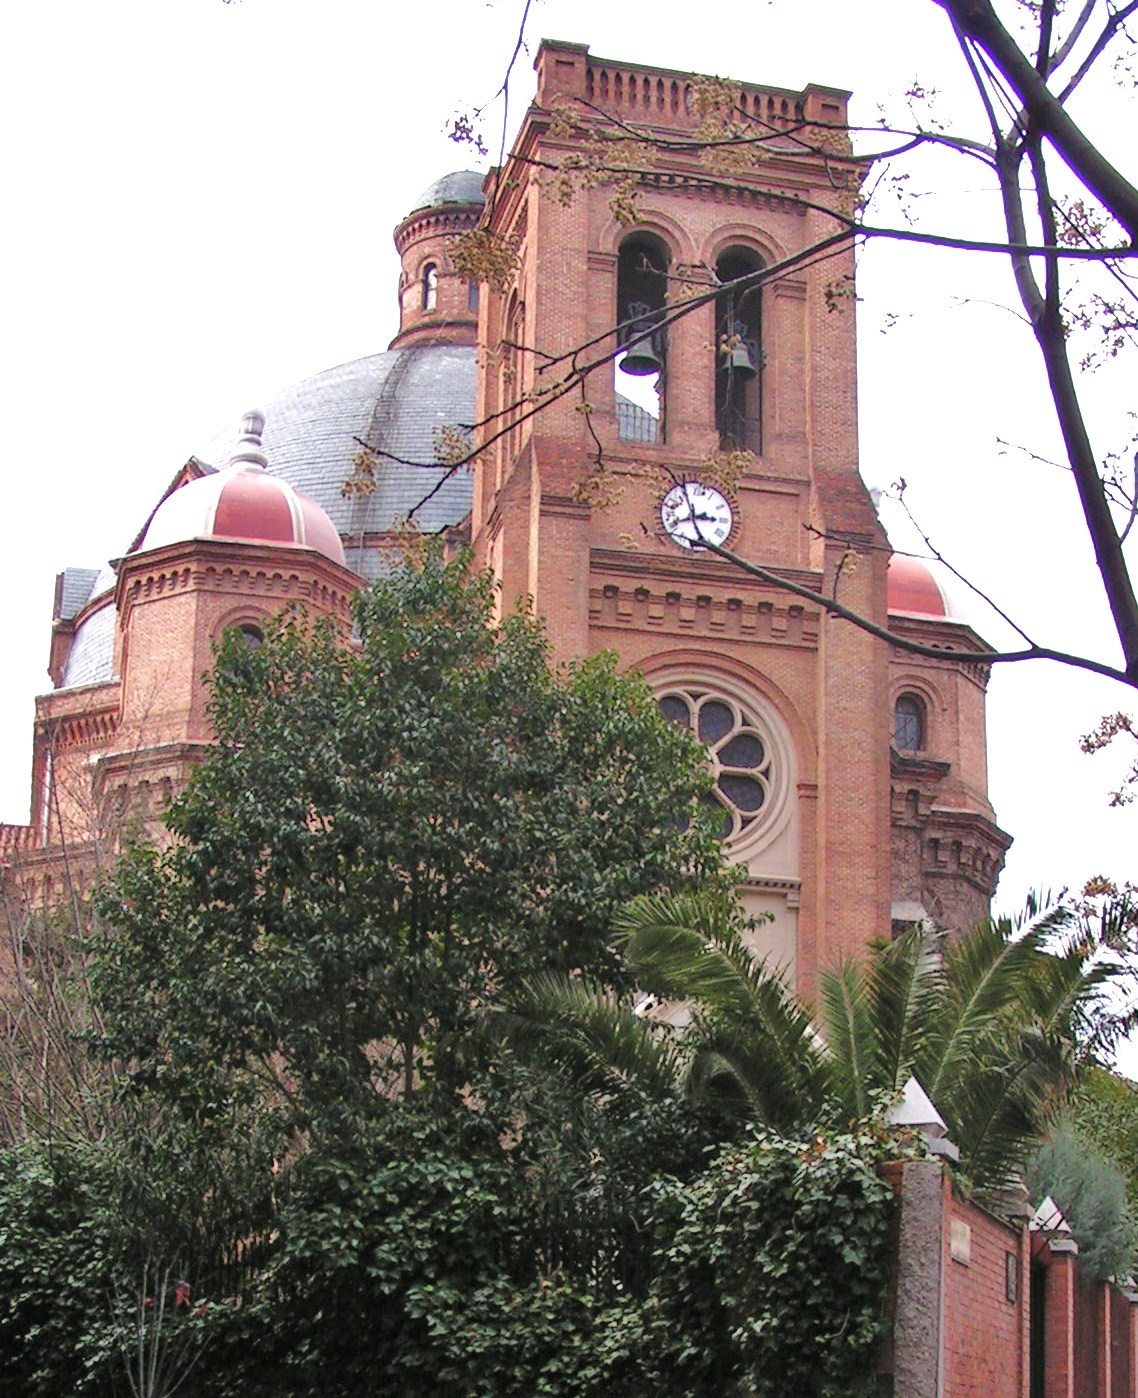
716, 247, 763, 452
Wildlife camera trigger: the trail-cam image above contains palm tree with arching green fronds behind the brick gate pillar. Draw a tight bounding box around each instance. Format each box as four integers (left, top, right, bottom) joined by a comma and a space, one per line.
505, 895, 1123, 1190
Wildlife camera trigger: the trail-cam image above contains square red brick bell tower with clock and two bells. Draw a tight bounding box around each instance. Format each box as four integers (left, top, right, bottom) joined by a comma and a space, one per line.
471, 42, 891, 994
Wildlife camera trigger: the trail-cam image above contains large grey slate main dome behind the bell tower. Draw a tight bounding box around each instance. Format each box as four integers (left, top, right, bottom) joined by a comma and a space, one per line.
196, 345, 477, 570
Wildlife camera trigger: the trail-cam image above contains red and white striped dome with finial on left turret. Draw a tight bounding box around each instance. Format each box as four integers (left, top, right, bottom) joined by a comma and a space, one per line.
137, 412, 344, 563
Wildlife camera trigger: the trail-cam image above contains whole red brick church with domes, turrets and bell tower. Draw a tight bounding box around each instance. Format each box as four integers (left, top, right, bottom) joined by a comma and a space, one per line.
0, 42, 1009, 994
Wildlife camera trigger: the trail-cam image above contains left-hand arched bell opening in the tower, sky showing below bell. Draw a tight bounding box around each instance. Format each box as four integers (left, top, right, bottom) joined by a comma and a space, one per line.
614, 233, 668, 442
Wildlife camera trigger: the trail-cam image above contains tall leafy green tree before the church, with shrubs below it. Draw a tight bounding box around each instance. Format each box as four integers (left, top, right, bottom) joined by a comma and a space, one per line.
0, 548, 726, 1398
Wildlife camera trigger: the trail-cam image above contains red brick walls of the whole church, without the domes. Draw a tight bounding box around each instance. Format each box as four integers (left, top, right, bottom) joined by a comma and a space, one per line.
4, 43, 1007, 994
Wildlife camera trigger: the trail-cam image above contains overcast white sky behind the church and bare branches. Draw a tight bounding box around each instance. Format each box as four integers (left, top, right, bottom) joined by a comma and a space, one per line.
0, 0, 1138, 950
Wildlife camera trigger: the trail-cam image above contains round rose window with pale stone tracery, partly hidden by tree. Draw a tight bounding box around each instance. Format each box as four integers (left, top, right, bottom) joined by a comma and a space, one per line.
658, 689, 772, 840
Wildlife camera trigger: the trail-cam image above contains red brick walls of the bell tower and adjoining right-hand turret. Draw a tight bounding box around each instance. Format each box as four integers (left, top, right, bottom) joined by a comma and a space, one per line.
471, 45, 1007, 994
